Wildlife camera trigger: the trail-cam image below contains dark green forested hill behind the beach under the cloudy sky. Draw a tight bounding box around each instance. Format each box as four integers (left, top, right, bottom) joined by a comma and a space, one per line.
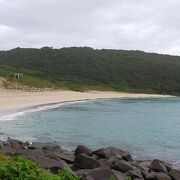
0, 47, 180, 94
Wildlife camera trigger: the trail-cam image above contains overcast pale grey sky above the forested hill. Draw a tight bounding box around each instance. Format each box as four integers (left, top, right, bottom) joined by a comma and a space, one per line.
0, 0, 180, 55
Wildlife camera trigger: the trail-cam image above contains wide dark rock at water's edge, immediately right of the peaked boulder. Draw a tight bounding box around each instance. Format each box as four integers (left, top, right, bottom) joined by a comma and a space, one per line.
93, 147, 133, 161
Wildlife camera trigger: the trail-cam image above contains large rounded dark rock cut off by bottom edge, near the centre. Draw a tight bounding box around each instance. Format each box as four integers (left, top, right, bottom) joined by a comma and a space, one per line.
82, 167, 121, 180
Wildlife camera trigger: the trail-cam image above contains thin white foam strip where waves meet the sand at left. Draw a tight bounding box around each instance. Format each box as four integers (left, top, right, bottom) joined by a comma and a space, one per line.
0, 100, 87, 121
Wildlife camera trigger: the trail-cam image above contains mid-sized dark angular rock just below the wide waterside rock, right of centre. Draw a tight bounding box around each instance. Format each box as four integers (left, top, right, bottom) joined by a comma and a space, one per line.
113, 160, 133, 173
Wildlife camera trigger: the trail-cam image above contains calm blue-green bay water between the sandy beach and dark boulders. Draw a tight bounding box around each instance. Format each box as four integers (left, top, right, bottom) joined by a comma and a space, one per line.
0, 98, 180, 166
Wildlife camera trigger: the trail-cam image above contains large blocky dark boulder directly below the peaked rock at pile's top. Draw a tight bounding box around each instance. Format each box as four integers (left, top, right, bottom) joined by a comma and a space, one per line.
74, 154, 100, 169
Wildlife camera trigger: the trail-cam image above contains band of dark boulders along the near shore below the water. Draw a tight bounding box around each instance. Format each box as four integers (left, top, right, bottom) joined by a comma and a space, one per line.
0, 138, 180, 180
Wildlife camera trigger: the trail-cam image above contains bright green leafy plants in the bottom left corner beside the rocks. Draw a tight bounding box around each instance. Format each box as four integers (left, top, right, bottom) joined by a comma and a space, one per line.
0, 152, 80, 180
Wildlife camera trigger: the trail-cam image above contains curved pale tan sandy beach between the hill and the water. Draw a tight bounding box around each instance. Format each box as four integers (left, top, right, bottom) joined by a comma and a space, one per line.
0, 88, 170, 115
